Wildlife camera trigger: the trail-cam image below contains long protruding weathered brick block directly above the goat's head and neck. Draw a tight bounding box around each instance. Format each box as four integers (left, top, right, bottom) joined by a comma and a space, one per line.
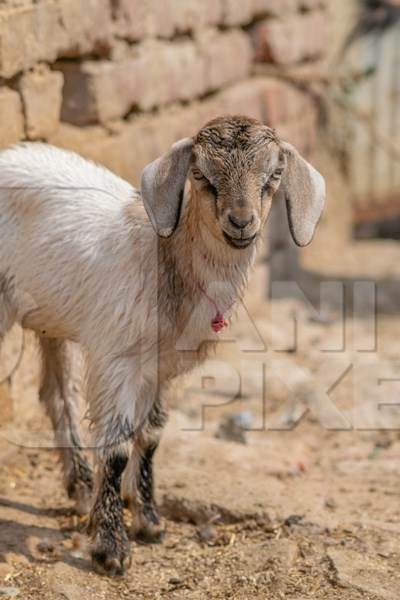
58, 30, 252, 125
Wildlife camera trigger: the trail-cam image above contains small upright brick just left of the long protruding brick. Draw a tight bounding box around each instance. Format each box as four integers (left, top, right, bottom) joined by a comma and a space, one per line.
18, 65, 63, 140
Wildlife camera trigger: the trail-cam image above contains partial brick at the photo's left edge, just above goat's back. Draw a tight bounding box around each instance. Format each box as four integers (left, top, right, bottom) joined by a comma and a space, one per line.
0, 87, 24, 148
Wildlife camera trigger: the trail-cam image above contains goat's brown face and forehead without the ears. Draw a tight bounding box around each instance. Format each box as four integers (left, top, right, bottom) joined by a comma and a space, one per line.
190, 116, 286, 248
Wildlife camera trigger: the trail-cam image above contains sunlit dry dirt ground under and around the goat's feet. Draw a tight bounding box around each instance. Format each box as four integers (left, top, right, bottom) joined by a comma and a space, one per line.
0, 231, 400, 600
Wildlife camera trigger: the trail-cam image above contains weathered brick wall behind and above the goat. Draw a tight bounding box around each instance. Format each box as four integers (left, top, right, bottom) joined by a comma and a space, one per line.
0, 0, 329, 414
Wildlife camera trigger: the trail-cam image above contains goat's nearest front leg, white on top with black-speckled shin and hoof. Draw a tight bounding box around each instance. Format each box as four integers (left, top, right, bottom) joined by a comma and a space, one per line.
88, 361, 154, 575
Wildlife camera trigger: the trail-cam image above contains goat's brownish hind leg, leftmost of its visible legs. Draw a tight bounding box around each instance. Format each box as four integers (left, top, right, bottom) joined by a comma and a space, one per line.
40, 338, 93, 514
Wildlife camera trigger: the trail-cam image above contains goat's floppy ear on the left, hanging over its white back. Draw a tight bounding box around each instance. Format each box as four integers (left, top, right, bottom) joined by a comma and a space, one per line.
141, 138, 193, 237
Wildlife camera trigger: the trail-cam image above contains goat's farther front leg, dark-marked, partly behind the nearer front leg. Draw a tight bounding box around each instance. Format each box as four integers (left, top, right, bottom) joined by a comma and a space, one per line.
122, 400, 167, 544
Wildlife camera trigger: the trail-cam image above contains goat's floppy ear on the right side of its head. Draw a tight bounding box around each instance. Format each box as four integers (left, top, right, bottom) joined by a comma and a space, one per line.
282, 144, 326, 246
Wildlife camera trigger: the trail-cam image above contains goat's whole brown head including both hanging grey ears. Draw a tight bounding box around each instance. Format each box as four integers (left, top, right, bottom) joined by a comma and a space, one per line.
142, 116, 325, 248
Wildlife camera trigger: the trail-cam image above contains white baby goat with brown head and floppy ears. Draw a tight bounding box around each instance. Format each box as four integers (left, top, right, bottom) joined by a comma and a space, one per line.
0, 116, 325, 575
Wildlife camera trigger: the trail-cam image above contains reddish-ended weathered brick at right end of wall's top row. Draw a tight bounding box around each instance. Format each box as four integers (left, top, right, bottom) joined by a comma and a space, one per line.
252, 11, 328, 65
